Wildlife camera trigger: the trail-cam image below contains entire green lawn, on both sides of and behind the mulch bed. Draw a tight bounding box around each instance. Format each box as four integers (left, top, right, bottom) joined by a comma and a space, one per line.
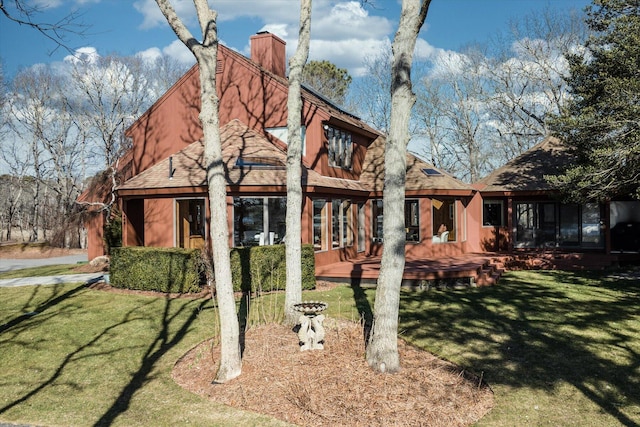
0, 272, 640, 426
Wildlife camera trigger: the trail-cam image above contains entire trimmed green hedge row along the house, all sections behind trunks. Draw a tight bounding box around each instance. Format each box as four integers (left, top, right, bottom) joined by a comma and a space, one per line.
110, 245, 316, 293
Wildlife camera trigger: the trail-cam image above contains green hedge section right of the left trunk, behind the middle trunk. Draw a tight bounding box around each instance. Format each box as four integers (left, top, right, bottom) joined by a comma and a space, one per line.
231, 245, 316, 292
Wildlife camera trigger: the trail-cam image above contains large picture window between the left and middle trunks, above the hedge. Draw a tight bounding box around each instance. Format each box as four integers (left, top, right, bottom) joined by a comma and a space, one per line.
233, 197, 287, 247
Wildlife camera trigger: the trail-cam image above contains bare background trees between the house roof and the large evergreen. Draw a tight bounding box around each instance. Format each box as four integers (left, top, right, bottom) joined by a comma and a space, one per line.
348, 5, 589, 182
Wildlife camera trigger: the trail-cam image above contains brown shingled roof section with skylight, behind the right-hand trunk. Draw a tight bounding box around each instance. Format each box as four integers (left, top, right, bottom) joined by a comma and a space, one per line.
360, 137, 473, 194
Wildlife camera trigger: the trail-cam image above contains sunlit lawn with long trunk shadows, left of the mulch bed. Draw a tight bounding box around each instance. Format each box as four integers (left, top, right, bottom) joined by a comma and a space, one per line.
0, 284, 285, 426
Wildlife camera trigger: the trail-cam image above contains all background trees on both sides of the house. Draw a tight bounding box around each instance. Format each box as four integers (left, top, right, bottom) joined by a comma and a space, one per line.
0, 1, 637, 245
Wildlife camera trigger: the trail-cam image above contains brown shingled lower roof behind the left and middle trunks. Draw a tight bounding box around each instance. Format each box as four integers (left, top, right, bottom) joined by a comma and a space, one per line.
118, 120, 368, 193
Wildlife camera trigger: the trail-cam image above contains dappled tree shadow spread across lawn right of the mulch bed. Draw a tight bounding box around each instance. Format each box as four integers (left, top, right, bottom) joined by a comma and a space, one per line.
400, 272, 640, 426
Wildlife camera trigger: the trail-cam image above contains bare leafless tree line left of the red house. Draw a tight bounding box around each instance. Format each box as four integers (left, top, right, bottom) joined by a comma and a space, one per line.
0, 50, 186, 247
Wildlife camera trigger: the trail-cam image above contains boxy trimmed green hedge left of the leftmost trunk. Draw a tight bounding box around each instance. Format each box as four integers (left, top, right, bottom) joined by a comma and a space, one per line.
109, 246, 201, 293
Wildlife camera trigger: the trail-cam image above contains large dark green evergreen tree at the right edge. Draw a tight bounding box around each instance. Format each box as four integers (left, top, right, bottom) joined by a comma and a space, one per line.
548, 0, 640, 201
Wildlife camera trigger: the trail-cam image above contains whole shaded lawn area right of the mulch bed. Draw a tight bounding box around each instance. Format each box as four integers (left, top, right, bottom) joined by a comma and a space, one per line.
400, 272, 640, 426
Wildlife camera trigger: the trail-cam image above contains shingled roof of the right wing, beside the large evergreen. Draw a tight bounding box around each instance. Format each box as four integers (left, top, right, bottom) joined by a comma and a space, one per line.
474, 136, 575, 192
